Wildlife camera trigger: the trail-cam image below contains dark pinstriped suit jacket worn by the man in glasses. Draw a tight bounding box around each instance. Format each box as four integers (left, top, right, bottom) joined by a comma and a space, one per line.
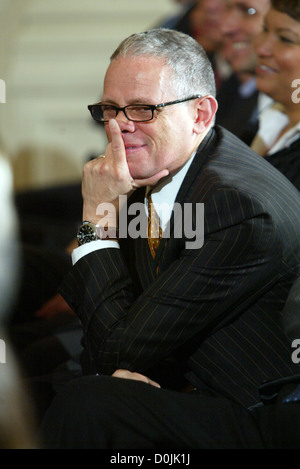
61, 127, 300, 407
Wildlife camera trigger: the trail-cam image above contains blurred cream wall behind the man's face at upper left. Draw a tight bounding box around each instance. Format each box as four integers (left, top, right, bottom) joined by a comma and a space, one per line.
0, 0, 178, 188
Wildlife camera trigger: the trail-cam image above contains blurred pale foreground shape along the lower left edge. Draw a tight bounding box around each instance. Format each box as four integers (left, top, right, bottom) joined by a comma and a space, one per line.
0, 155, 36, 449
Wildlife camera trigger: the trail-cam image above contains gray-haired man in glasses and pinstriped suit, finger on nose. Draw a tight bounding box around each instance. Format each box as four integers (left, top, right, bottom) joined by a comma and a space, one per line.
41, 29, 300, 449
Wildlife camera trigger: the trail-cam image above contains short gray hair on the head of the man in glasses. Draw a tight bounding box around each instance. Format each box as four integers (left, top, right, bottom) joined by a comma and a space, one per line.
110, 28, 216, 97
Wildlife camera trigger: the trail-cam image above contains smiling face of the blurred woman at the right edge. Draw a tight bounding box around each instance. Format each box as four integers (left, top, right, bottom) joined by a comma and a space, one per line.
255, 8, 300, 107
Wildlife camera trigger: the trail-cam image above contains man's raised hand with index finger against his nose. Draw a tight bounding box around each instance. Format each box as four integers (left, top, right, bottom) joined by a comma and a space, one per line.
82, 119, 169, 227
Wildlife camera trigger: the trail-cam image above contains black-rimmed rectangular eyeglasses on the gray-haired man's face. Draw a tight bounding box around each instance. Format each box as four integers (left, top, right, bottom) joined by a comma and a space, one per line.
88, 95, 202, 122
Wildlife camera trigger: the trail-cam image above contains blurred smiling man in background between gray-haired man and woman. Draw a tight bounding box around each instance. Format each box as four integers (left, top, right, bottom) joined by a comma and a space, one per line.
216, 0, 270, 145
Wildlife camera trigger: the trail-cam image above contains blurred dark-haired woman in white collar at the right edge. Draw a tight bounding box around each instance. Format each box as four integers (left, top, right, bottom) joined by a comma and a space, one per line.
252, 0, 300, 190
